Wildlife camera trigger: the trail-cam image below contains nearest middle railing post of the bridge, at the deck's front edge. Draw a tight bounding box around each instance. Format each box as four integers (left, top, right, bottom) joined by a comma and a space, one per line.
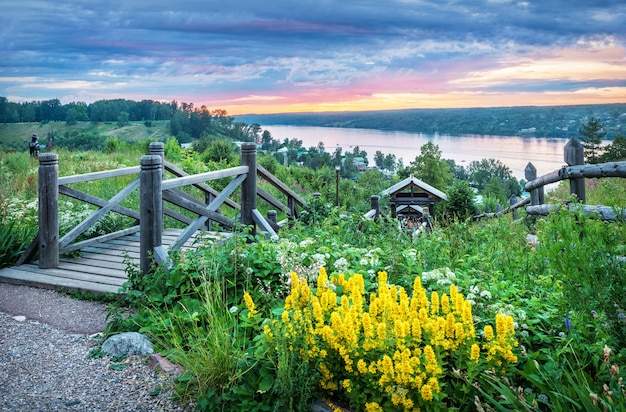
139, 155, 163, 274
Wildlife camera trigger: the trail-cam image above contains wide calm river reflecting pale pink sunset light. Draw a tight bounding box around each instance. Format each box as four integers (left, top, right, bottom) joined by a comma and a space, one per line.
263, 126, 584, 179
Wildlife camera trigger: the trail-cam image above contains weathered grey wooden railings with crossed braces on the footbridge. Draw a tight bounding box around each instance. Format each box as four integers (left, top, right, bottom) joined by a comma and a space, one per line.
18, 142, 306, 273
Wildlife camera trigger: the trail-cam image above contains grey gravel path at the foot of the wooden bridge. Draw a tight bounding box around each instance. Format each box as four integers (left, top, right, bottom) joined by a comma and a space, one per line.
0, 283, 189, 412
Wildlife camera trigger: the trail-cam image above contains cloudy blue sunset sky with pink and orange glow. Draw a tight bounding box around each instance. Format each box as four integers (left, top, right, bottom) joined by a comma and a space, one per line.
0, 0, 626, 115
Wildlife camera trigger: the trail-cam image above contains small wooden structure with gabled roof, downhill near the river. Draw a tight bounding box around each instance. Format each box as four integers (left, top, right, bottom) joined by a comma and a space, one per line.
381, 175, 448, 223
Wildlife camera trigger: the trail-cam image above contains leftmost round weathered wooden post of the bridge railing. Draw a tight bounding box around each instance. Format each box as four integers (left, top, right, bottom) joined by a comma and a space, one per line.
38, 153, 59, 269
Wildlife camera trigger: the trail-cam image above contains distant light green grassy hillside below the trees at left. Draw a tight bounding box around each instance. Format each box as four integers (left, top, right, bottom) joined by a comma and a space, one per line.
0, 120, 171, 151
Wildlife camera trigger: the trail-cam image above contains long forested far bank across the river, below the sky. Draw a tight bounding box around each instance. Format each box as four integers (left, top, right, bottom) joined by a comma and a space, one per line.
239, 104, 626, 140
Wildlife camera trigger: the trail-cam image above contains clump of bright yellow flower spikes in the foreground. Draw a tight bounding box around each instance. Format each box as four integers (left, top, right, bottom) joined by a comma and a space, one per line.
265, 269, 517, 411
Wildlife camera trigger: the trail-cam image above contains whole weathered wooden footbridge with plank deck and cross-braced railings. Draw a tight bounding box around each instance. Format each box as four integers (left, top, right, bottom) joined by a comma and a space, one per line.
0, 142, 305, 293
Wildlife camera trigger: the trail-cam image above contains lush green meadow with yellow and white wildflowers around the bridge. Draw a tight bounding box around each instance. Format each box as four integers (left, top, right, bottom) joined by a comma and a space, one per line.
0, 143, 626, 411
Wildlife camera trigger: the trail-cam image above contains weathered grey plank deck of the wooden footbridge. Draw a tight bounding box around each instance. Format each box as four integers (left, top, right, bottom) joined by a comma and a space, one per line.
0, 229, 232, 293
